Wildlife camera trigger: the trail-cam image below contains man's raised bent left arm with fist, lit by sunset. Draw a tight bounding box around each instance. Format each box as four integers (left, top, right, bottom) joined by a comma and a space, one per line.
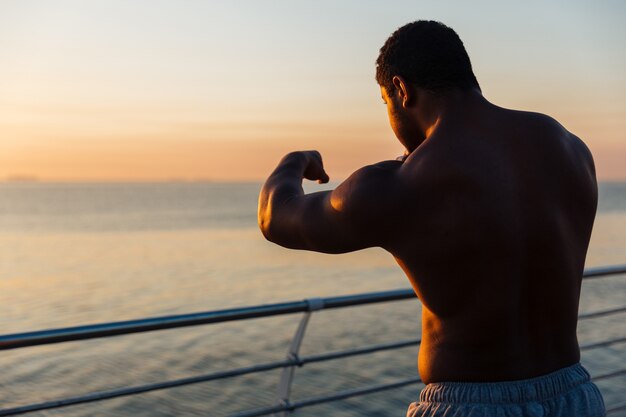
258, 151, 402, 253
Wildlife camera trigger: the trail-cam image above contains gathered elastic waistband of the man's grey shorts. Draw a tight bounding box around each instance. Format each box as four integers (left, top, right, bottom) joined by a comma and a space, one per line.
420, 363, 591, 404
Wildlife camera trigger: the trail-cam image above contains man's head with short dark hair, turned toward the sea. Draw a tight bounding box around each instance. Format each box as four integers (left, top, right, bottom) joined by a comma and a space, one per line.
376, 20, 480, 152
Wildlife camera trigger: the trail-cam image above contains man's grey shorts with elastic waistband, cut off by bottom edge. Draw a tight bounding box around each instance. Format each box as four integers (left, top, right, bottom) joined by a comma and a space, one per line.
406, 364, 605, 417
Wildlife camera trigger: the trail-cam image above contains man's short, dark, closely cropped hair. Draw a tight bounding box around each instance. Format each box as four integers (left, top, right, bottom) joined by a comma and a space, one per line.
376, 20, 480, 93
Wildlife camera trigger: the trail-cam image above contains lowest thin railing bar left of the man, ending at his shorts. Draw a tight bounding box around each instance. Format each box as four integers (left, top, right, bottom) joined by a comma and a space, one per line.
229, 377, 422, 417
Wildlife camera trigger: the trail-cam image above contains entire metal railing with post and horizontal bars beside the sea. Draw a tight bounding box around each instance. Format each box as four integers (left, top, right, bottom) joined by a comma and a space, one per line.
0, 265, 626, 417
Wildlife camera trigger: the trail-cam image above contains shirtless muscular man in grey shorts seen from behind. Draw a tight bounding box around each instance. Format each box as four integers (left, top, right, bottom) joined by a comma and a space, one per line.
259, 21, 604, 417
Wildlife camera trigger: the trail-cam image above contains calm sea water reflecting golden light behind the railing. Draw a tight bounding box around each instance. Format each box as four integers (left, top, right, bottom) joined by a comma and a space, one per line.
0, 183, 626, 417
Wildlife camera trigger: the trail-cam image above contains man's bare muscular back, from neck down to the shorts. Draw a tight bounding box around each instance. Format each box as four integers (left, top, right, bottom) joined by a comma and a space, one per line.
386, 104, 597, 383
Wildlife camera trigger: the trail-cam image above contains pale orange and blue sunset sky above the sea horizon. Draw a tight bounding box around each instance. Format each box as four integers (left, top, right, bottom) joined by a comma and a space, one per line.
0, 0, 626, 181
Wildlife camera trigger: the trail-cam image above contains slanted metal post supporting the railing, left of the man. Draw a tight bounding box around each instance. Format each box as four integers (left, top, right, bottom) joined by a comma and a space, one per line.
275, 298, 324, 417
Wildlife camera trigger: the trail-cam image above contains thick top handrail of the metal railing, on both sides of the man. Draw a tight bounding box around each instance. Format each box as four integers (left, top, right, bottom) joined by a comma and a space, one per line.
0, 265, 626, 350
